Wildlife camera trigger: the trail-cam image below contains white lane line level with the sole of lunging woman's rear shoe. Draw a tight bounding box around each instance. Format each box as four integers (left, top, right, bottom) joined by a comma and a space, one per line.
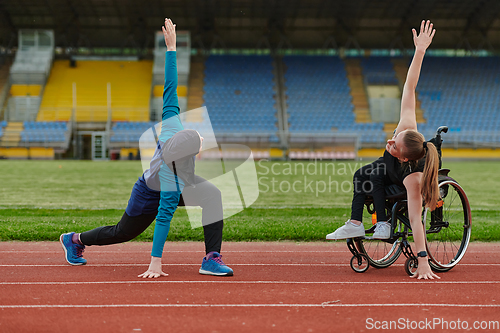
0, 263, 500, 267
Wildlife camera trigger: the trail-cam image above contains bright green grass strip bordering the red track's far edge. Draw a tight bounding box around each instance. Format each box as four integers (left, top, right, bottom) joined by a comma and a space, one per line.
0, 208, 500, 241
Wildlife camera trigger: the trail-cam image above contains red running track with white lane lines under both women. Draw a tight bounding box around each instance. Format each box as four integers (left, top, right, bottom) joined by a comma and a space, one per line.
0, 242, 500, 333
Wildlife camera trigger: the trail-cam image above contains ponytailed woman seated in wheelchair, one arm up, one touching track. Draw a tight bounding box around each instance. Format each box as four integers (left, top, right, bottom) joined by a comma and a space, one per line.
326, 21, 439, 279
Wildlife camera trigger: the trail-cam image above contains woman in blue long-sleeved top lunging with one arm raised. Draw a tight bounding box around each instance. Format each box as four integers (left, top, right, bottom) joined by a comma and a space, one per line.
60, 19, 233, 278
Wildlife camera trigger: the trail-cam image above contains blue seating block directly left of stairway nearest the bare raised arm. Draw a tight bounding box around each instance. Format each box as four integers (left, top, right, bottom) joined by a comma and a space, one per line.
283, 56, 385, 143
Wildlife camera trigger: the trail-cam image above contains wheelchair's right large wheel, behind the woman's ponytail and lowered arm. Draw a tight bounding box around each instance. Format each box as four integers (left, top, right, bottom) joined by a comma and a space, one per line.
424, 176, 471, 272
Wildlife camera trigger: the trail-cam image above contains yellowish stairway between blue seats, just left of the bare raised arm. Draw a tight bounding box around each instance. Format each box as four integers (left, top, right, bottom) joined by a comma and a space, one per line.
344, 58, 371, 123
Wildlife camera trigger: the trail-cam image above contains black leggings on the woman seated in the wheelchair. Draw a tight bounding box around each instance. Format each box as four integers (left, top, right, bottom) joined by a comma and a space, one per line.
351, 157, 390, 222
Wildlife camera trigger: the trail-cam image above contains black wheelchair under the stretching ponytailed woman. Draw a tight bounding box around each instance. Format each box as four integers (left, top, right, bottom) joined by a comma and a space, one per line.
347, 126, 472, 276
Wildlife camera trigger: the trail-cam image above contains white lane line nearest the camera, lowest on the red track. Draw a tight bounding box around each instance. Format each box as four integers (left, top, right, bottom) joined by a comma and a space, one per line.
0, 302, 500, 309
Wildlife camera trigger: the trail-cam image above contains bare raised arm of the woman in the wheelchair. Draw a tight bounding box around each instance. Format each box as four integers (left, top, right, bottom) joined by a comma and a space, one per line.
395, 20, 436, 134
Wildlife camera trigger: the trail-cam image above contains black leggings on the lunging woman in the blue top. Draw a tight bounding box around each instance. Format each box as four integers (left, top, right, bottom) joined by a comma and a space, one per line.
80, 176, 224, 253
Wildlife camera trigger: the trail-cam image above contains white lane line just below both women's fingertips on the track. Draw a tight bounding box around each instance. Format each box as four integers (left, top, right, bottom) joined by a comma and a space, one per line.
0, 280, 500, 286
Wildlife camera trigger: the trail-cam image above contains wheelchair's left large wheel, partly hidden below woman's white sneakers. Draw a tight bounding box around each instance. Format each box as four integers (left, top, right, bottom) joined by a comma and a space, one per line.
356, 221, 408, 268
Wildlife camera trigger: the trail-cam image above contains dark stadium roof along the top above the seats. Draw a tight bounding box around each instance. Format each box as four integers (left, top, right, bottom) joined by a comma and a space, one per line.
0, 0, 500, 50
